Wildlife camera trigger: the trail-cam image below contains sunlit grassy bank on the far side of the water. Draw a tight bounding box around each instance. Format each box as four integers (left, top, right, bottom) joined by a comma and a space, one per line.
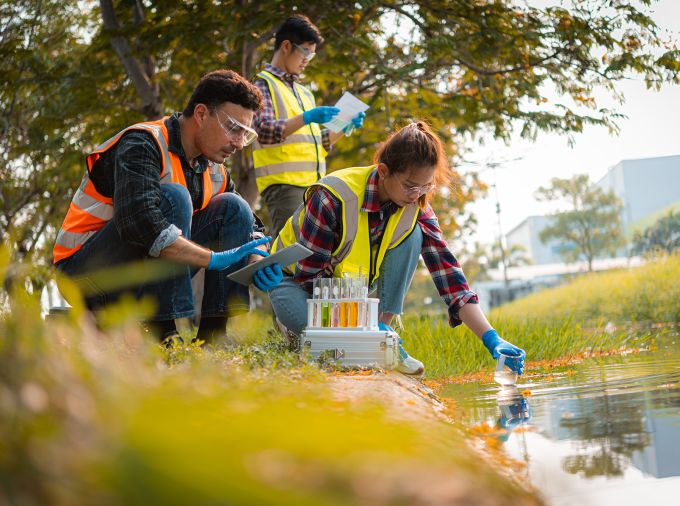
403, 255, 680, 378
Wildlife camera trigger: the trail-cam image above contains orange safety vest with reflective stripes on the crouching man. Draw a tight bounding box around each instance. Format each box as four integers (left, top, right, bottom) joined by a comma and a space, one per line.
52, 117, 227, 263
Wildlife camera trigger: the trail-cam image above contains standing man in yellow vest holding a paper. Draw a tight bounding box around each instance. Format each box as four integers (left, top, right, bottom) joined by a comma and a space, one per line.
253, 14, 365, 237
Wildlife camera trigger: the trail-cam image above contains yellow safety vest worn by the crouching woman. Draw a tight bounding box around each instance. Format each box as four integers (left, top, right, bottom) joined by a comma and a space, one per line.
272, 165, 420, 283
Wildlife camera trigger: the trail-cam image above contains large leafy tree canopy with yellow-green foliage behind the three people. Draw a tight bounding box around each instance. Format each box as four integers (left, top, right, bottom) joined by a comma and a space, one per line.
0, 0, 680, 272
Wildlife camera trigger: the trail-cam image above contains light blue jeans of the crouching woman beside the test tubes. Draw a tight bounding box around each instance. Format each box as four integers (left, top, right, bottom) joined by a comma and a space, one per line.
269, 226, 423, 336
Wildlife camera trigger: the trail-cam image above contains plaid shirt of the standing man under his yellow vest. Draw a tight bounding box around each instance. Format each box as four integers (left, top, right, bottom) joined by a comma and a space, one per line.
253, 63, 331, 151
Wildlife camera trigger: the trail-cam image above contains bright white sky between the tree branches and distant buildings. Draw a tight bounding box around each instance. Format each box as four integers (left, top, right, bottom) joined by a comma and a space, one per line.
458, 0, 680, 244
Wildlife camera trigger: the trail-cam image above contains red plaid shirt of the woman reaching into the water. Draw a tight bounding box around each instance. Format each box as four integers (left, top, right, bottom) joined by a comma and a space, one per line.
295, 170, 479, 327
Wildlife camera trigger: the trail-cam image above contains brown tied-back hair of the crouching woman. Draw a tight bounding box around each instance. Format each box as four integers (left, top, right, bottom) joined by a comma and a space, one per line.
374, 121, 453, 208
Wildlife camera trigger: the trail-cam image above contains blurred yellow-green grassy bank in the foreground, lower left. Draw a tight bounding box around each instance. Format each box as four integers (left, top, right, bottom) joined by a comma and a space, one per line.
0, 253, 540, 506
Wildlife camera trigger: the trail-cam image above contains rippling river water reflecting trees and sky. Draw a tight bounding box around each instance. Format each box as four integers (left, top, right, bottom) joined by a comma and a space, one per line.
440, 335, 680, 506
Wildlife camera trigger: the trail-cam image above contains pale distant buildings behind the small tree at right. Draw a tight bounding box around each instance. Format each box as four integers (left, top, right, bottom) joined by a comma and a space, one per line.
505, 155, 680, 265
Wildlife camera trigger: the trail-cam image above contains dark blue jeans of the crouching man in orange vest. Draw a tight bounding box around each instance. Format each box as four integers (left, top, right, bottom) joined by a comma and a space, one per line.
57, 184, 254, 321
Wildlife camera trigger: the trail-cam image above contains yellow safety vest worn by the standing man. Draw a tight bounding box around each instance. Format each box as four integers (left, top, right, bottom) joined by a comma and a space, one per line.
253, 70, 327, 193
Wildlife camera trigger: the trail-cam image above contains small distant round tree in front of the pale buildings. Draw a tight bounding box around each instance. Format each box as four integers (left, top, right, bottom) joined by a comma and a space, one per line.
536, 174, 624, 271
